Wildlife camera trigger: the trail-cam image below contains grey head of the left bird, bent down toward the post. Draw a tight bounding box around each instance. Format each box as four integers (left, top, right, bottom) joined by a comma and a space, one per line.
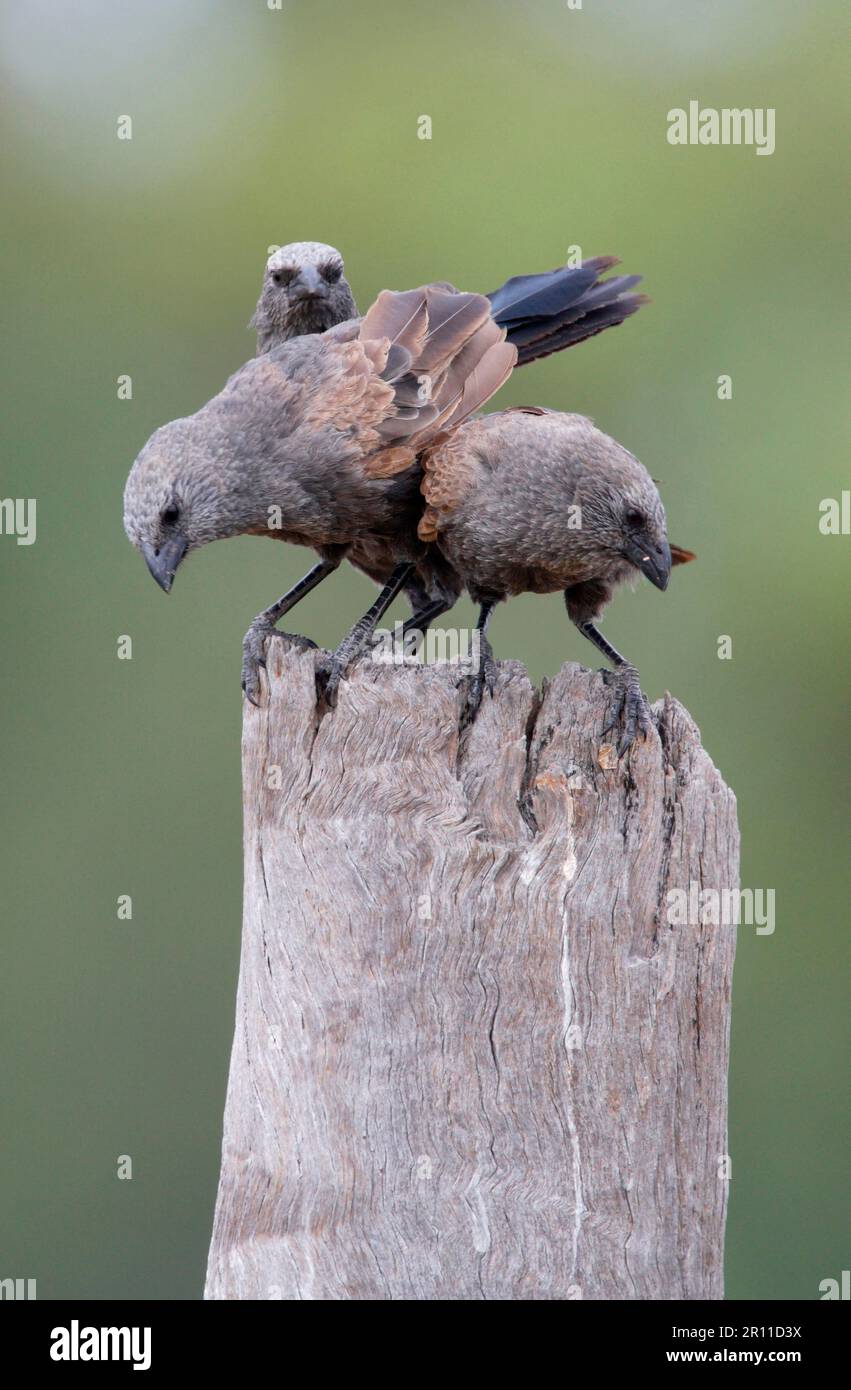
124, 417, 242, 594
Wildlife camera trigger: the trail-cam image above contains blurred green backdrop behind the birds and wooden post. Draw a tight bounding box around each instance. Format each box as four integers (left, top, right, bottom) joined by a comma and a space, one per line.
0, 0, 851, 1298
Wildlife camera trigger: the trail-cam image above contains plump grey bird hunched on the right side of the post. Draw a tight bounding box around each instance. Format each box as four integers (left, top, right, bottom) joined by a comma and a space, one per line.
417, 406, 695, 758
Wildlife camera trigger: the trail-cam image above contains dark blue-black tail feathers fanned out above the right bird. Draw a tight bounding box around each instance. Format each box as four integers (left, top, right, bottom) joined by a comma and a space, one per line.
488, 256, 649, 367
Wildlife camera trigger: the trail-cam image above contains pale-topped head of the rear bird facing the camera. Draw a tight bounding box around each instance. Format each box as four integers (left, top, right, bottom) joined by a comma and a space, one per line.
252, 242, 357, 345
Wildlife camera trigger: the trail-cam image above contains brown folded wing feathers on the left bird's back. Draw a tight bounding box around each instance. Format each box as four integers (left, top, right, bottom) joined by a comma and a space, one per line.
357, 284, 517, 477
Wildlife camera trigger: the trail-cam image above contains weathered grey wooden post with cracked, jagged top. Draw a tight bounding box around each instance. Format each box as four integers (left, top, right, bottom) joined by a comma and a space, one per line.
206, 641, 738, 1300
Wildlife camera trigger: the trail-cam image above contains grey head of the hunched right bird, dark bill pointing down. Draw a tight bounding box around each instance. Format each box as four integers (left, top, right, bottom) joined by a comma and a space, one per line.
577, 446, 672, 589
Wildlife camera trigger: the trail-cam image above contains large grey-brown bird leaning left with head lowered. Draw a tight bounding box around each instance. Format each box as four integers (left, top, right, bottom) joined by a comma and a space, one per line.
124, 285, 517, 702
